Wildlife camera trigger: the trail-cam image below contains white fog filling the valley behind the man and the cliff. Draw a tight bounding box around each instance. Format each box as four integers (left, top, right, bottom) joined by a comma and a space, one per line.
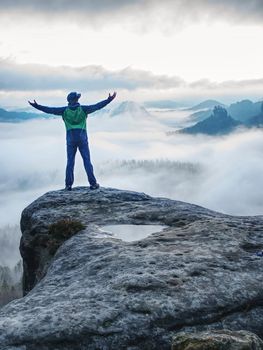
0, 111, 263, 268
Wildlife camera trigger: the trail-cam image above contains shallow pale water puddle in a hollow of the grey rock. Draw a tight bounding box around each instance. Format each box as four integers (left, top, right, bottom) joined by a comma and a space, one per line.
99, 225, 167, 242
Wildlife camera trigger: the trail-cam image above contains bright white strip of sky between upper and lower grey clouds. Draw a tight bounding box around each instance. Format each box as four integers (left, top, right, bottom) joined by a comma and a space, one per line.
0, 18, 263, 82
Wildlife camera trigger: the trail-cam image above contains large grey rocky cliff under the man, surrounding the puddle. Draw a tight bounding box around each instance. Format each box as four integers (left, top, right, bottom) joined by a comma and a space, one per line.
0, 188, 263, 350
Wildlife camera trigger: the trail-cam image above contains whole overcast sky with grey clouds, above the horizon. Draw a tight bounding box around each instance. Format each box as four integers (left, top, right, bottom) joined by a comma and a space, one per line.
0, 0, 263, 107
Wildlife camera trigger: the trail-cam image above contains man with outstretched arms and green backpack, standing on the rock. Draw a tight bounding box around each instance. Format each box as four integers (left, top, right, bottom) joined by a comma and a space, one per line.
28, 92, 116, 191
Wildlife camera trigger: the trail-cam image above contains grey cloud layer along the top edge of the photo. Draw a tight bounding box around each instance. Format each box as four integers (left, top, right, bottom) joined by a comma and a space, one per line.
0, 0, 263, 28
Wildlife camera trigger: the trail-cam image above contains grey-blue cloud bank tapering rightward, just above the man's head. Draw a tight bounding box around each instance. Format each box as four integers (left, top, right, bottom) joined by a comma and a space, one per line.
0, 59, 184, 91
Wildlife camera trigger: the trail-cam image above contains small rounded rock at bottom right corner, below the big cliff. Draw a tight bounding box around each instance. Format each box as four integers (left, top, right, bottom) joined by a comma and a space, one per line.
172, 330, 263, 350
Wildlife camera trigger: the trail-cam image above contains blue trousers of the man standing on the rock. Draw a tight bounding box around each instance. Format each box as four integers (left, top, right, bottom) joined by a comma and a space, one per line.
65, 129, 97, 186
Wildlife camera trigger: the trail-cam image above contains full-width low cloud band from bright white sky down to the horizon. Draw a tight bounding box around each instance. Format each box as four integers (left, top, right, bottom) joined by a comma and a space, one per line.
0, 59, 263, 106
